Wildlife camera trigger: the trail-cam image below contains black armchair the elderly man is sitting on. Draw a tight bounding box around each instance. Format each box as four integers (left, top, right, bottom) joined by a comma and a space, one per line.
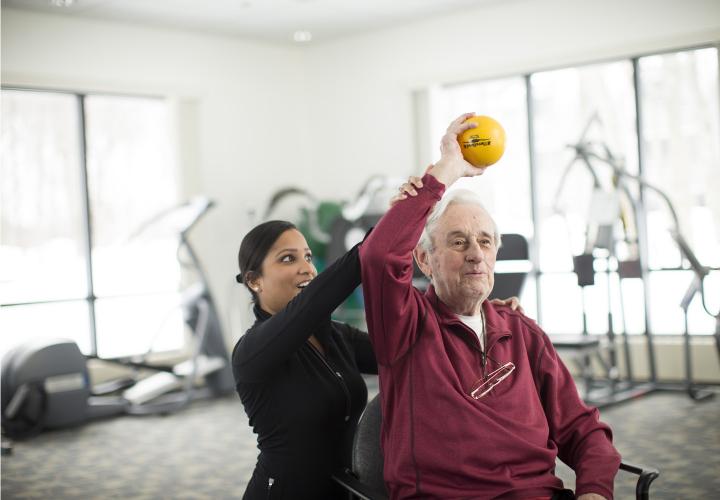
333, 394, 660, 500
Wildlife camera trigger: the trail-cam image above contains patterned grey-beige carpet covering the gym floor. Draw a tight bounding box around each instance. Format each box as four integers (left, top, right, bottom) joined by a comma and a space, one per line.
1, 378, 720, 500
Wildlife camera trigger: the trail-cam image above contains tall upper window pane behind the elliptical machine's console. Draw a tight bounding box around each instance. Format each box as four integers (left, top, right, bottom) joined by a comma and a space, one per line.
85, 96, 180, 296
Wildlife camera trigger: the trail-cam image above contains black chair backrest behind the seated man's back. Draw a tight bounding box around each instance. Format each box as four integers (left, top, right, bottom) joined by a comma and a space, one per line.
352, 394, 387, 495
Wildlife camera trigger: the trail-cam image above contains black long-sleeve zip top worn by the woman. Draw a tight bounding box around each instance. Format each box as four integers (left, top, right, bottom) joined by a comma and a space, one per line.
232, 247, 377, 500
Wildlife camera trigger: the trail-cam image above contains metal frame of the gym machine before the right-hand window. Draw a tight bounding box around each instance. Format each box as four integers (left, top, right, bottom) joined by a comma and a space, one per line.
555, 116, 720, 407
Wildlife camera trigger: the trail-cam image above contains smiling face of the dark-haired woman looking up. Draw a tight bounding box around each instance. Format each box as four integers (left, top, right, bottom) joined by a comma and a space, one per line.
250, 229, 317, 314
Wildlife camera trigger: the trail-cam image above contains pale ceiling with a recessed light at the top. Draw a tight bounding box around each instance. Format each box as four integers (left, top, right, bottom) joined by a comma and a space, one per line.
2, 0, 508, 44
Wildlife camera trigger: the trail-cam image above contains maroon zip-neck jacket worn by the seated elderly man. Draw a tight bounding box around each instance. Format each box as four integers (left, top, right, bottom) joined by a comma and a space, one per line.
360, 175, 620, 499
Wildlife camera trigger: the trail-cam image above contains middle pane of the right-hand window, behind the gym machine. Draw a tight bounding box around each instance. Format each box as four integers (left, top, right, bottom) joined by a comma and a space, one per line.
530, 61, 638, 334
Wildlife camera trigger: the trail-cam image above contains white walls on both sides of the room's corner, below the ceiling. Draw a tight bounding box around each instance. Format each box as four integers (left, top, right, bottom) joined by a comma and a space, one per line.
2, 0, 720, 354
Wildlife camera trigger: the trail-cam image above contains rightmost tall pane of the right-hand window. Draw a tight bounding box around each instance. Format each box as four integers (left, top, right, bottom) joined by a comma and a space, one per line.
639, 48, 720, 268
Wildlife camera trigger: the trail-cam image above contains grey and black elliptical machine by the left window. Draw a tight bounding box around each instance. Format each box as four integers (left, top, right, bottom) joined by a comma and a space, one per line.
1, 198, 234, 440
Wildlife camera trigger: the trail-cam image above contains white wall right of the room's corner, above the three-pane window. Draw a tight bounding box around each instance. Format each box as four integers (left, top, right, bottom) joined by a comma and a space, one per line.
306, 0, 720, 189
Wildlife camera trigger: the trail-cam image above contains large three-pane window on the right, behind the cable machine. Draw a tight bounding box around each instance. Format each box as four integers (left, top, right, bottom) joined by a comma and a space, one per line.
429, 48, 720, 334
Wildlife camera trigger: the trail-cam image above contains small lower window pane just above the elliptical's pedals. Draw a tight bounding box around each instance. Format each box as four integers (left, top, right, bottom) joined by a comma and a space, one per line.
95, 294, 184, 358
